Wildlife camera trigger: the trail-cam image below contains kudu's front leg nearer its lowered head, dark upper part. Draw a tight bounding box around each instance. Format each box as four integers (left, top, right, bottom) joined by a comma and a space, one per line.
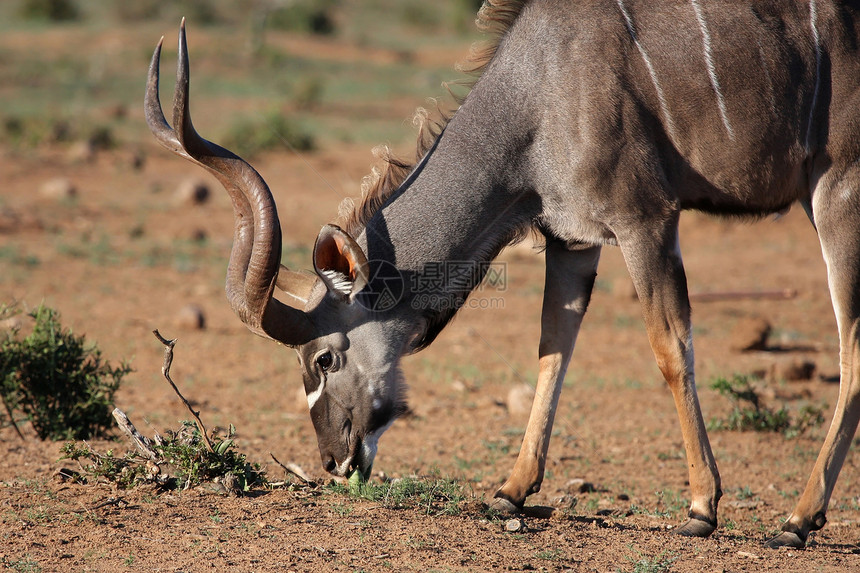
491, 240, 600, 512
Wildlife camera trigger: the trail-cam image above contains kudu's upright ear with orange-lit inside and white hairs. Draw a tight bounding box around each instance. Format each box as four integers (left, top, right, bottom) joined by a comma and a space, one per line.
314, 225, 368, 300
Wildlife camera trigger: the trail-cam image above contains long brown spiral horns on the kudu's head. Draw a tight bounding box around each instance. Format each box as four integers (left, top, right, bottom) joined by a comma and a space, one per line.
144, 18, 314, 346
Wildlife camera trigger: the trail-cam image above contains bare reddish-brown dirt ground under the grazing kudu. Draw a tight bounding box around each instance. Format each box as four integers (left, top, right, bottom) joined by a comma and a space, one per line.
0, 14, 860, 572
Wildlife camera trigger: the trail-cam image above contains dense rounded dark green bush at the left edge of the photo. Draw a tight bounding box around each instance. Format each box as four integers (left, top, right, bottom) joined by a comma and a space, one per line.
0, 305, 131, 440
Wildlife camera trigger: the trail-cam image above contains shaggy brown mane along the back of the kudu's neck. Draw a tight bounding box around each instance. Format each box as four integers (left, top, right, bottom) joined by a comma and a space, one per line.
338, 0, 528, 237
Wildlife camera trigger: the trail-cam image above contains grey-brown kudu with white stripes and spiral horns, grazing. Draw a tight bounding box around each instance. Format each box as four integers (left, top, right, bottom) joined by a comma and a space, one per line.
145, 0, 860, 547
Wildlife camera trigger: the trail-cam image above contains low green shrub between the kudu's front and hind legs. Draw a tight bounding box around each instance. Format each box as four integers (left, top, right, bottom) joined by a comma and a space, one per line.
708, 374, 824, 437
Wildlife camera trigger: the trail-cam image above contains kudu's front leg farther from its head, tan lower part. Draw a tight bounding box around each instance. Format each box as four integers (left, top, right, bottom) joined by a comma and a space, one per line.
619, 218, 722, 537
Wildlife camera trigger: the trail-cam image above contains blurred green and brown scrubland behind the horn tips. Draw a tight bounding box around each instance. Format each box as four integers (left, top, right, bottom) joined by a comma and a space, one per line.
0, 0, 481, 156
